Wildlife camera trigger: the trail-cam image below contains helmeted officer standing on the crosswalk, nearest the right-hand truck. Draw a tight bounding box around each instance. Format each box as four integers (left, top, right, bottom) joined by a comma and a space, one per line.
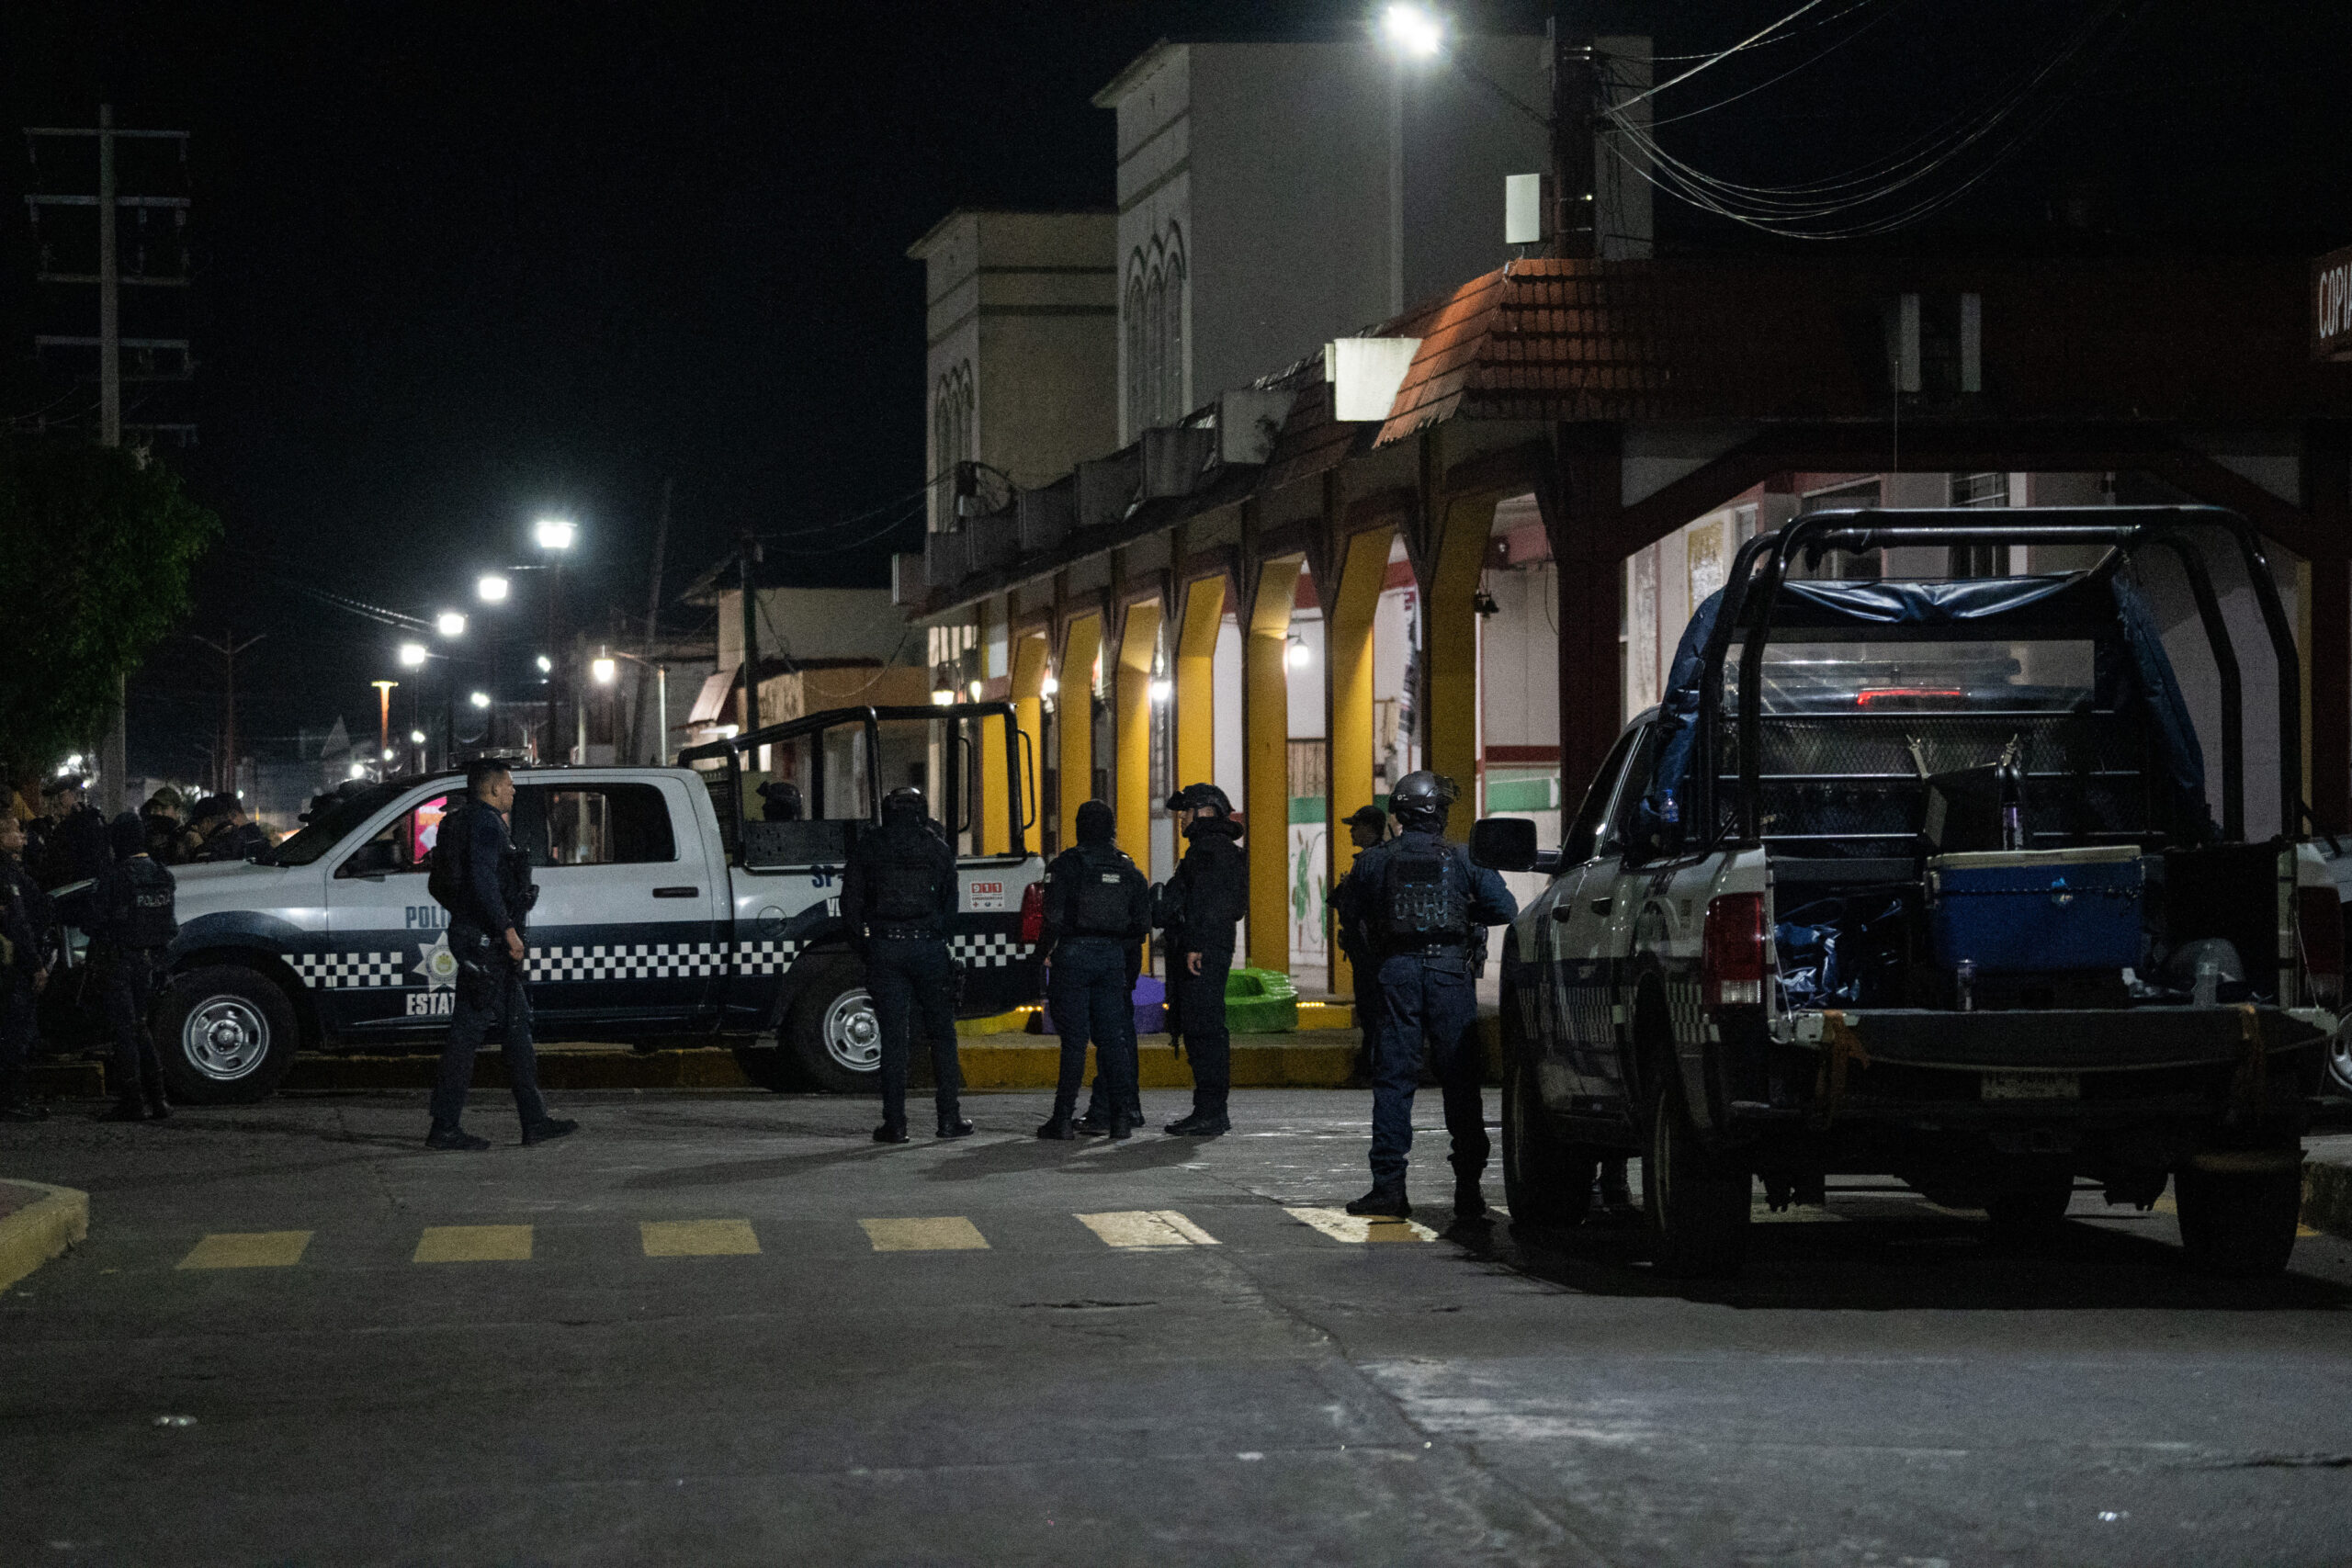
1339, 771, 1520, 1220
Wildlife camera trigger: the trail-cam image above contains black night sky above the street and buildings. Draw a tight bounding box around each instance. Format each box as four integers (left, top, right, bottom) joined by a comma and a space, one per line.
0, 0, 2352, 771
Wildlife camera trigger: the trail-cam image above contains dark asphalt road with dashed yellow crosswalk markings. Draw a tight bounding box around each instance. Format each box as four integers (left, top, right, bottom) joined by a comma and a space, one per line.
0, 1090, 2352, 1568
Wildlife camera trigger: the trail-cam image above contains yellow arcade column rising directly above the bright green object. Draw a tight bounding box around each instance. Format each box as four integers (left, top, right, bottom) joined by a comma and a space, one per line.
1242, 555, 1306, 974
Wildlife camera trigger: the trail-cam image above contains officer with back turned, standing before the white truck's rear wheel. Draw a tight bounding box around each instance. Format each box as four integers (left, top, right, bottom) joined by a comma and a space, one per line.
842, 785, 971, 1143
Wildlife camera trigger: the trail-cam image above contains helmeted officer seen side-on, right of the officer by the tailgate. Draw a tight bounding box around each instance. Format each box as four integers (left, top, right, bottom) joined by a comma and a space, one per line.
1159, 783, 1249, 1138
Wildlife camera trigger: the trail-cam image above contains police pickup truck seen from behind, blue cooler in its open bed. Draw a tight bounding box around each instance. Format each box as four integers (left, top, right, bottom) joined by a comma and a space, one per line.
1473, 508, 2345, 1274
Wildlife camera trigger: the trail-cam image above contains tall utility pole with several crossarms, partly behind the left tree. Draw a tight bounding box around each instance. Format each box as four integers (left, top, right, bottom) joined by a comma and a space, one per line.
24, 104, 193, 816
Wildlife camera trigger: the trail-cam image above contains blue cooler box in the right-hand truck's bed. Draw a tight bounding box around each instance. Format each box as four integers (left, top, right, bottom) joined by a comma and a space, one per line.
1927, 844, 2145, 976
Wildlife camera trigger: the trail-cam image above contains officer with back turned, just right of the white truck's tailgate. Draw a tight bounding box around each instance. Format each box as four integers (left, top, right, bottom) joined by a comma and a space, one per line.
1037, 799, 1152, 1140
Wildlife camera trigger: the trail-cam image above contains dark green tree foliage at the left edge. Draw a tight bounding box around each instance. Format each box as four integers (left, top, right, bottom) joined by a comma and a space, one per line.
0, 440, 221, 773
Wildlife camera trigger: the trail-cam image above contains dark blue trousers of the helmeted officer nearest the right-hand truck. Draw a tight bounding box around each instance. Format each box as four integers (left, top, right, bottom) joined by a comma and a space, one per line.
1371, 952, 1487, 1187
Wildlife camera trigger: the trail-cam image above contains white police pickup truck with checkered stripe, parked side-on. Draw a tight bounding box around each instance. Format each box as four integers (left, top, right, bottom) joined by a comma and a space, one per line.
133, 703, 1045, 1105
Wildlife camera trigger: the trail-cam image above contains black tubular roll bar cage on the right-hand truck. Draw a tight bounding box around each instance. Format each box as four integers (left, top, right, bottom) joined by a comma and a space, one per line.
1684, 505, 2310, 844
